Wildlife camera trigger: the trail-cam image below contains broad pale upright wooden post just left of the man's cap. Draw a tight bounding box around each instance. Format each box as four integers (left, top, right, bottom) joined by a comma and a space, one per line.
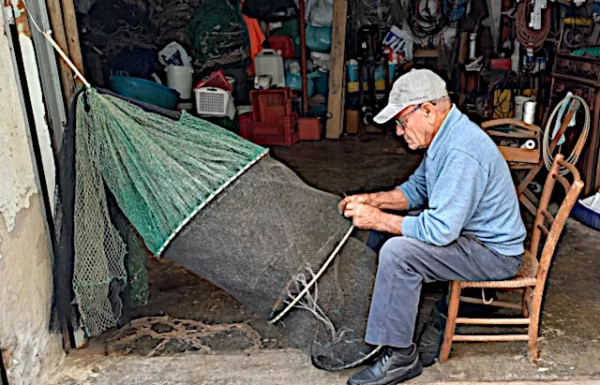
325, 0, 348, 139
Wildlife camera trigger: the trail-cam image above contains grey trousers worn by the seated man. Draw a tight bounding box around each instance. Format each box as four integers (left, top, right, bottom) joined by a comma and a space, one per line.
365, 236, 523, 347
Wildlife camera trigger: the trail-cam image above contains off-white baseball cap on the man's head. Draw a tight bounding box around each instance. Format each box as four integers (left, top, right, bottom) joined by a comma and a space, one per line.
373, 69, 448, 124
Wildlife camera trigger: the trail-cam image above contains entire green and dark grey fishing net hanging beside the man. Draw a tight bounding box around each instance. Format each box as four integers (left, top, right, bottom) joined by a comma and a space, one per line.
62, 90, 377, 370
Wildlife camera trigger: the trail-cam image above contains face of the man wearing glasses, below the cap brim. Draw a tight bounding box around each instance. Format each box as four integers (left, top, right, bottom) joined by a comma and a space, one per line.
396, 104, 433, 150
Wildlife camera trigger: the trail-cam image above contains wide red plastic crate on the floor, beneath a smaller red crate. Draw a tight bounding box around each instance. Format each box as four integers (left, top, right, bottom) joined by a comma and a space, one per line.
240, 114, 298, 147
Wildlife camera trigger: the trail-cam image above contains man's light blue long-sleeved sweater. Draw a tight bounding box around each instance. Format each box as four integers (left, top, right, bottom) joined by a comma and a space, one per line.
398, 106, 525, 255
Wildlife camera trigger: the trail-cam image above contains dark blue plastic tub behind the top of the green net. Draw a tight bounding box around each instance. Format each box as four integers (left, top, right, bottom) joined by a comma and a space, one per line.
110, 75, 179, 110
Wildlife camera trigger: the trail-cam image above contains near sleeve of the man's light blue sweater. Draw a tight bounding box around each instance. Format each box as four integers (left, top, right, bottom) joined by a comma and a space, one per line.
402, 150, 488, 246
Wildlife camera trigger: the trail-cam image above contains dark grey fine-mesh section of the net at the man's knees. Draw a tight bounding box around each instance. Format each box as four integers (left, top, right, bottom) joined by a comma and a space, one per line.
163, 157, 376, 370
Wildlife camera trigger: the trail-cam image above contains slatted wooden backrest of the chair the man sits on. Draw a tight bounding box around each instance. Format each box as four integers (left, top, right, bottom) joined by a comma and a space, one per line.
526, 154, 583, 282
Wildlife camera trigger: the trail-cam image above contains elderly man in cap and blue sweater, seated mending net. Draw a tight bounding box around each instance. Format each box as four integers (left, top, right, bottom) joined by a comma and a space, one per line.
339, 70, 525, 385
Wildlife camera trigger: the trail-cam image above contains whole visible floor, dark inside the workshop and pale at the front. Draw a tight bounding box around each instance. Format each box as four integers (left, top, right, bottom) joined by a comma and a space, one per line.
47, 135, 600, 385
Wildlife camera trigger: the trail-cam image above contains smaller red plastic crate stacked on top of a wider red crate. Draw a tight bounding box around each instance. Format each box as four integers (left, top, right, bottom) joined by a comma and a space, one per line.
250, 87, 292, 122
